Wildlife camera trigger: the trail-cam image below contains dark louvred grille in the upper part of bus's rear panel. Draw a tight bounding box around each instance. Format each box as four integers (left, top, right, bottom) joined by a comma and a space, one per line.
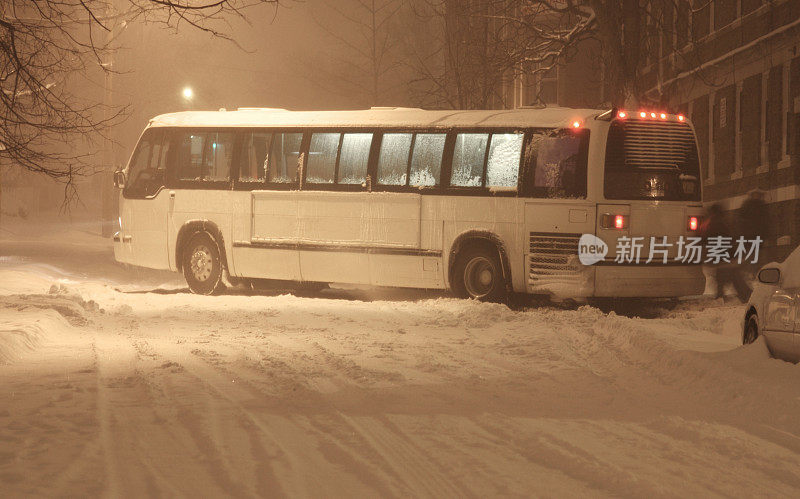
625, 120, 694, 168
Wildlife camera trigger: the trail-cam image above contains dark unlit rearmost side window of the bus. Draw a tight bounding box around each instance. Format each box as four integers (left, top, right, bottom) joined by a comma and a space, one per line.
527, 132, 586, 198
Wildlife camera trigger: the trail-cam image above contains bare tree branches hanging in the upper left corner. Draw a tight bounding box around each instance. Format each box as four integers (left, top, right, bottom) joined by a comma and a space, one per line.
0, 0, 278, 201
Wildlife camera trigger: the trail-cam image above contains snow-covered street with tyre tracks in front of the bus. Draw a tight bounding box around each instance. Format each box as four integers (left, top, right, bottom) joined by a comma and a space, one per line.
0, 221, 800, 497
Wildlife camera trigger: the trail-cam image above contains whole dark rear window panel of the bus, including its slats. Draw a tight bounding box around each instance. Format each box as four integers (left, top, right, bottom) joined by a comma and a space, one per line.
603, 119, 700, 201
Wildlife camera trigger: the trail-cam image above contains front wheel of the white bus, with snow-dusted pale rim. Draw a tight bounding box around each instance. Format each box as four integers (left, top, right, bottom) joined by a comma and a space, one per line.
182, 232, 225, 295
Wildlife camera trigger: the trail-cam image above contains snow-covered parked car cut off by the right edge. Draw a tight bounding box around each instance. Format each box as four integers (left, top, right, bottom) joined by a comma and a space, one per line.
742, 247, 800, 362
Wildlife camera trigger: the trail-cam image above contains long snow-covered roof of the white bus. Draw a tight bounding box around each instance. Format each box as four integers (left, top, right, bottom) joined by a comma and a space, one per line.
150, 107, 603, 128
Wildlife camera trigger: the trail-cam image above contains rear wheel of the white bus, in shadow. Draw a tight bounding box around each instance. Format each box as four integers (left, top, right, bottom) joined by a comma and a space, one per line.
451, 246, 506, 302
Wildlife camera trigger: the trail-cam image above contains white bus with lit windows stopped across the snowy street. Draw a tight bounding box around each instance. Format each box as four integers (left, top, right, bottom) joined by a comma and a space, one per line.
114, 108, 704, 300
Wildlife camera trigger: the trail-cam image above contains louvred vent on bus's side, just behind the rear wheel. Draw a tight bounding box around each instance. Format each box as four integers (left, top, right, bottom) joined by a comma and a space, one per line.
528, 232, 581, 284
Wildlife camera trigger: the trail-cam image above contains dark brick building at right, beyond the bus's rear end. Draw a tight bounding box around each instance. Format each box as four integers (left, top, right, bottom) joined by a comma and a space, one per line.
664, 0, 800, 264
